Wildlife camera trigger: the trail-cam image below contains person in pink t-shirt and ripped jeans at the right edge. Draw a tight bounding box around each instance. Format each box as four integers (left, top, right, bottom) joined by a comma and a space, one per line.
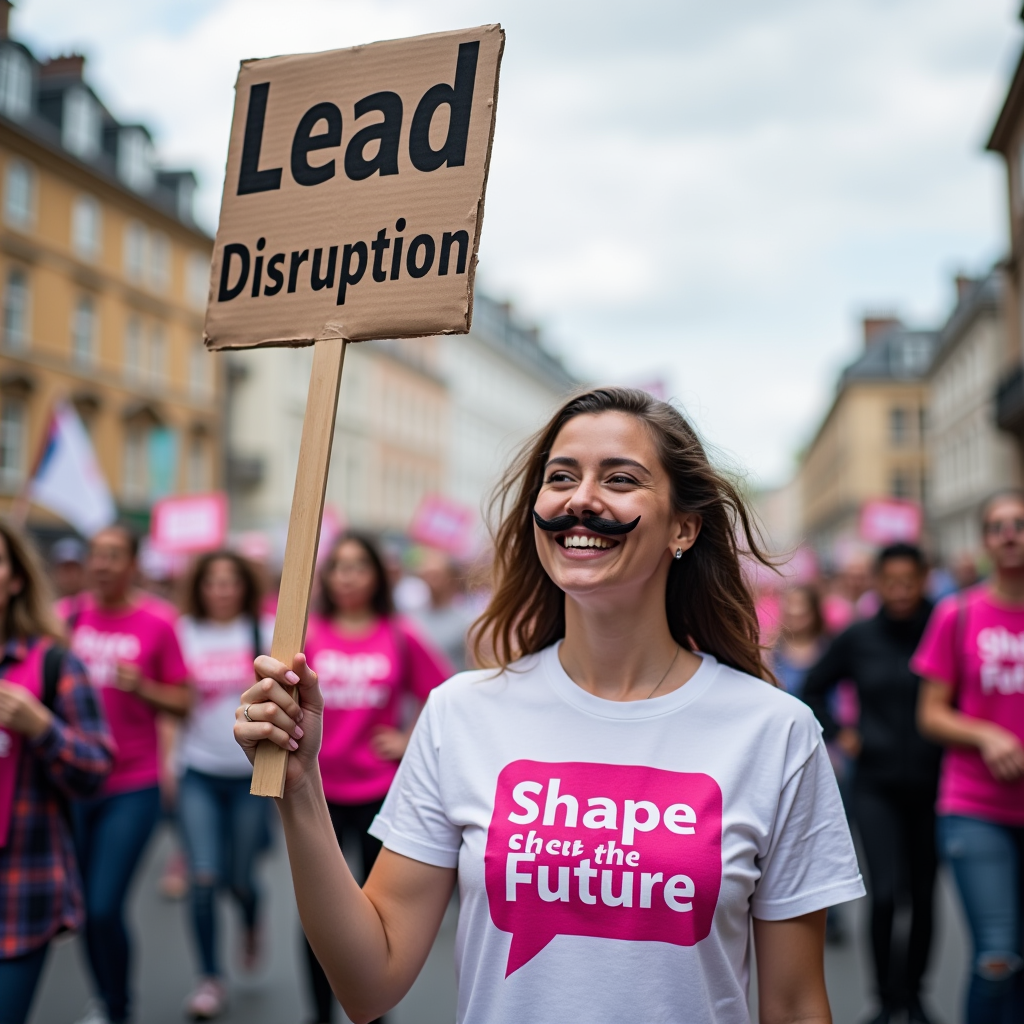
911, 490, 1024, 1024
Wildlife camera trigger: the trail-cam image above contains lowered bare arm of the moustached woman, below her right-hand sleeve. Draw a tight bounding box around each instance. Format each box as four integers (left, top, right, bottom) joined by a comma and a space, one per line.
754, 910, 831, 1024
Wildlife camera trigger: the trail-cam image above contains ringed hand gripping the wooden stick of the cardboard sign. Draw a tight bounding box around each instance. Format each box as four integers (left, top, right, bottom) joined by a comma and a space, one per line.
234, 654, 324, 793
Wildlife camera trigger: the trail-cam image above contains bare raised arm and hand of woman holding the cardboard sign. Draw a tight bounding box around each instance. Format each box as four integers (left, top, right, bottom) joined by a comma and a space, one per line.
234, 654, 456, 1024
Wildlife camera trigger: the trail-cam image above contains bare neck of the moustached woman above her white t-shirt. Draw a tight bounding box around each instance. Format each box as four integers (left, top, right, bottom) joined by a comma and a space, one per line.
558, 586, 700, 700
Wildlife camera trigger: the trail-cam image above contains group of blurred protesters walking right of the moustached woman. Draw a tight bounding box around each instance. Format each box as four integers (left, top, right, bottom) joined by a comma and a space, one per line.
771, 492, 1024, 1024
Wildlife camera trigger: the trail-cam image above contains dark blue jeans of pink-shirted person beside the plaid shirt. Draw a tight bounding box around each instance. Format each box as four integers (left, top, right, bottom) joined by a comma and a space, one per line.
72, 785, 160, 1024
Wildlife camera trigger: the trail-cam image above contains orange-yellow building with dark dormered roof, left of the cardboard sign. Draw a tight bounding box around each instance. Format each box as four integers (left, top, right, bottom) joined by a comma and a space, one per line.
0, 39, 221, 525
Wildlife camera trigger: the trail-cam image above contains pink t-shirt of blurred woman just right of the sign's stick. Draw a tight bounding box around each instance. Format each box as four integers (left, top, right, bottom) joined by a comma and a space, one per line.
305, 616, 452, 804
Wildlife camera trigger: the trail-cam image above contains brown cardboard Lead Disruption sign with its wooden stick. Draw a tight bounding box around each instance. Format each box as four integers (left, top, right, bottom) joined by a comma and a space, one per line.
204, 25, 505, 797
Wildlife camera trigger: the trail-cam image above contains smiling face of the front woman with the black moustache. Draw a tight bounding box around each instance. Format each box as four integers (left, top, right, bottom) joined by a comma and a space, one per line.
534, 412, 700, 600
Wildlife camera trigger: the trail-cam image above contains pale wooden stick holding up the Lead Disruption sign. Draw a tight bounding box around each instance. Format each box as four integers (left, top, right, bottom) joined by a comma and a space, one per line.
250, 338, 347, 797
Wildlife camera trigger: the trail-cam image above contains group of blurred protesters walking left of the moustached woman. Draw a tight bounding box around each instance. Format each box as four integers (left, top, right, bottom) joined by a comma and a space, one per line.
0, 521, 460, 1024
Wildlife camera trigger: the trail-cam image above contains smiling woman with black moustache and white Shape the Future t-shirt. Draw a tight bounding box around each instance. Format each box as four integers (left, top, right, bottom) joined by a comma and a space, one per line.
234, 388, 863, 1024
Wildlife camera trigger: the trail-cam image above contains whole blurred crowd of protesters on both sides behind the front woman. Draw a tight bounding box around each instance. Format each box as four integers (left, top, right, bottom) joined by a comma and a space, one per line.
0, 492, 1024, 1024
